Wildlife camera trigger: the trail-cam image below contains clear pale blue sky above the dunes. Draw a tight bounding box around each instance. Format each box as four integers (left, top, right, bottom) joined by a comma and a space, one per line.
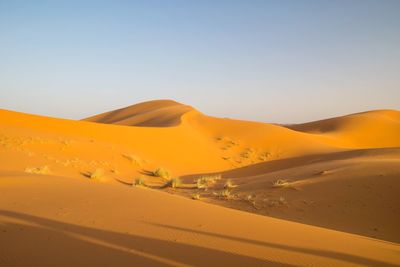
0, 0, 400, 123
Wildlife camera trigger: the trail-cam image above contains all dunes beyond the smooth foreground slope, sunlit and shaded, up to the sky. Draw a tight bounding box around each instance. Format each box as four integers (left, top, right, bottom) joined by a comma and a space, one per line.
0, 100, 400, 248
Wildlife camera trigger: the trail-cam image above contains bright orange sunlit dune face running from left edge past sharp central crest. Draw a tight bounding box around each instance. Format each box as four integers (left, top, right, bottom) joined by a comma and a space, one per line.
0, 101, 338, 182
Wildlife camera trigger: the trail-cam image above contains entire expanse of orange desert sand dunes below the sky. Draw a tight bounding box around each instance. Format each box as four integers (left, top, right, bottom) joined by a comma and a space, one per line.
0, 100, 400, 266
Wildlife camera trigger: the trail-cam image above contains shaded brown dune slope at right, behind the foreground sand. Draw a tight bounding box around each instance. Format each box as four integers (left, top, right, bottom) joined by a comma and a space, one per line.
182, 148, 400, 242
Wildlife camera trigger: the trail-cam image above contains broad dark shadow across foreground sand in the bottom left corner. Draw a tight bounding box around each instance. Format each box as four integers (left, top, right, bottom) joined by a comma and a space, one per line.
0, 210, 294, 267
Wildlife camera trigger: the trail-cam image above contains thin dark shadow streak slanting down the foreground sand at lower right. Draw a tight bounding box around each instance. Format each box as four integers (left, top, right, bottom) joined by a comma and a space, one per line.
147, 222, 400, 267
